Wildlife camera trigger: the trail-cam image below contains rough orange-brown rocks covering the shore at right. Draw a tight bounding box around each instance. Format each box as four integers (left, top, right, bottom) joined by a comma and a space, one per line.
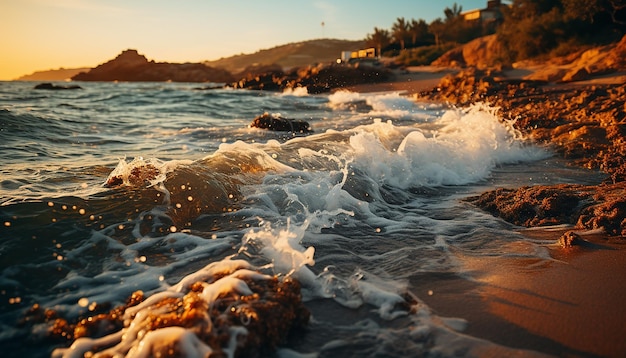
420, 68, 626, 236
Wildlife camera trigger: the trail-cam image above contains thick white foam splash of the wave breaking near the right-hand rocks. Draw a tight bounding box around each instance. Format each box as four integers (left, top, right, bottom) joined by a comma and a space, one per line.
350, 106, 549, 188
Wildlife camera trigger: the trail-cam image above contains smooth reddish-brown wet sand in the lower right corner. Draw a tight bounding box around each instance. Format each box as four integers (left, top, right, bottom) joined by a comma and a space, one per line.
414, 230, 626, 357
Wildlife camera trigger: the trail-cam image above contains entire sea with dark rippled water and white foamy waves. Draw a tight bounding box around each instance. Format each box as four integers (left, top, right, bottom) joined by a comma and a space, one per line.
0, 82, 598, 357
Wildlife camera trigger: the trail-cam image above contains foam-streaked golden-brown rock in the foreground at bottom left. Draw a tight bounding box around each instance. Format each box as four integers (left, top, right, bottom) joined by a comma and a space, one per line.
31, 260, 310, 357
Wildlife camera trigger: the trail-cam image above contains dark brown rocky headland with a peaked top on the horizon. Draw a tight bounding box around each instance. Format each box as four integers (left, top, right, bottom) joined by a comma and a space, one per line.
72, 49, 233, 82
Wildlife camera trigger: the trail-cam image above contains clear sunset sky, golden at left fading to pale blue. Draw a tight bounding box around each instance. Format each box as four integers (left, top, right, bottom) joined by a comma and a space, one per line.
0, 0, 487, 80
